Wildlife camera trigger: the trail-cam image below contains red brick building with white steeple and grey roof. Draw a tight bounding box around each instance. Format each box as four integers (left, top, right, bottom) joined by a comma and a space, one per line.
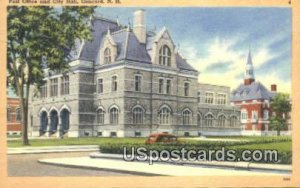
231, 51, 290, 135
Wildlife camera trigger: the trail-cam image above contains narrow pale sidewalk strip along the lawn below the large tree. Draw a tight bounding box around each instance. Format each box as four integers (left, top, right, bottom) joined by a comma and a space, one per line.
7, 145, 99, 155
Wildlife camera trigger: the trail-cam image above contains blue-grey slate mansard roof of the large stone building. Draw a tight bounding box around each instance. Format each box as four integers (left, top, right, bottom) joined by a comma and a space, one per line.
72, 18, 197, 71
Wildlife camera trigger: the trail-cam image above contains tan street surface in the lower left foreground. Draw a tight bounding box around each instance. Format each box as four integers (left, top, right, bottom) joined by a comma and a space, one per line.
7, 152, 141, 176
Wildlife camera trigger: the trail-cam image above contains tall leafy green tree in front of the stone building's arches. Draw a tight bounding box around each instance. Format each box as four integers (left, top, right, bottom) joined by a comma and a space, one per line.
7, 6, 95, 145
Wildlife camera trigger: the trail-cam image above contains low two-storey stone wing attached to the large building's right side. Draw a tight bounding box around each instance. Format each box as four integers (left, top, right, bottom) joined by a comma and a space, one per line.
198, 83, 241, 136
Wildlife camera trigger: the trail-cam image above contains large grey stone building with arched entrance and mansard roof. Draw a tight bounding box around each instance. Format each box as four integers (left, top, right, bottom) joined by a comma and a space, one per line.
29, 10, 241, 137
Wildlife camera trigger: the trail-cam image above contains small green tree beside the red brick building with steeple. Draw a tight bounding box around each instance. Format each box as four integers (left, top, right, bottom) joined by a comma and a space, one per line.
270, 93, 291, 136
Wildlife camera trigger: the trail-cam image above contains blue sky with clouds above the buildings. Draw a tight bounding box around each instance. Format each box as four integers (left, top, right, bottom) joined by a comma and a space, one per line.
97, 7, 291, 93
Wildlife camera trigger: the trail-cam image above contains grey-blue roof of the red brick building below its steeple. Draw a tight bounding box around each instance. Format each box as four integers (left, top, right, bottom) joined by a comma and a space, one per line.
231, 82, 276, 102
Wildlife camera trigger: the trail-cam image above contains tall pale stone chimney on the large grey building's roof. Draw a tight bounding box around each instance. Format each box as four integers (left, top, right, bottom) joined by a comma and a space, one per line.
133, 9, 146, 44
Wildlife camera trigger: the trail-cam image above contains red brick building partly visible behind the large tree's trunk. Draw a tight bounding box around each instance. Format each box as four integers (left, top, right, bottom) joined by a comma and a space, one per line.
6, 87, 22, 135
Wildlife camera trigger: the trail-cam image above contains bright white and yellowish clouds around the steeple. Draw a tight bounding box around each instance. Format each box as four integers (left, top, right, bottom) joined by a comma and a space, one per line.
180, 36, 290, 93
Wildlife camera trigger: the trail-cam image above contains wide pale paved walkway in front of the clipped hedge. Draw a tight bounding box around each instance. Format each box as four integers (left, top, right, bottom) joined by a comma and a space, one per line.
39, 157, 290, 176
